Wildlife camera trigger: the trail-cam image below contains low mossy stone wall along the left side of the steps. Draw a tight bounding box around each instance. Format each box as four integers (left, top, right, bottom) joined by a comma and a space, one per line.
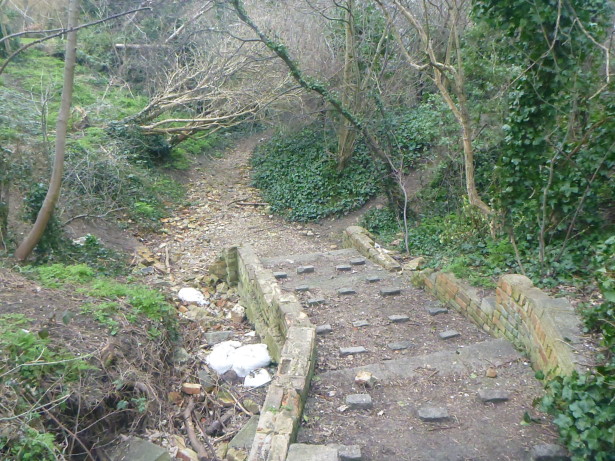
210, 247, 316, 461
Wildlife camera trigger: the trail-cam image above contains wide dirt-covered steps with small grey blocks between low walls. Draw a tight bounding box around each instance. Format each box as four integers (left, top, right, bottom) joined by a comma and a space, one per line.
262, 249, 564, 461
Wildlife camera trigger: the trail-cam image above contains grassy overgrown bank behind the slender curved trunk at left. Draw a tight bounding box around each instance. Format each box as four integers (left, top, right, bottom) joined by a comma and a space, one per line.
0, 43, 241, 253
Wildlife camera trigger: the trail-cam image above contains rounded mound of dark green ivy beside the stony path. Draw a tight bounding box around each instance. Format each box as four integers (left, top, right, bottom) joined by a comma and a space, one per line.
252, 128, 382, 221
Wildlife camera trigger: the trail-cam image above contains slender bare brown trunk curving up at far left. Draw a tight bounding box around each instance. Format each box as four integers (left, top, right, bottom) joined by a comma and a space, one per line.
15, 0, 79, 261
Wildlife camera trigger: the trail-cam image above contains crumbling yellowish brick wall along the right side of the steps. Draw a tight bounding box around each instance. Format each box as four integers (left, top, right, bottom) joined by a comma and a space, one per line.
412, 269, 583, 375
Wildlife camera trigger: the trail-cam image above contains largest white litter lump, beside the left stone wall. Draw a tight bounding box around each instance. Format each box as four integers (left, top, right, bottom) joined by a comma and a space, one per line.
205, 341, 271, 378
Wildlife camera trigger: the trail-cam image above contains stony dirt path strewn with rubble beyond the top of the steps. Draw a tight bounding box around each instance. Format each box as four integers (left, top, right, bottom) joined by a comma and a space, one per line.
145, 134, 358, 283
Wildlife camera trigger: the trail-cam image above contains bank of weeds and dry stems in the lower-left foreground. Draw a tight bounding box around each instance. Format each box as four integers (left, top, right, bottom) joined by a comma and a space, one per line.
0, 264, 178, 460
